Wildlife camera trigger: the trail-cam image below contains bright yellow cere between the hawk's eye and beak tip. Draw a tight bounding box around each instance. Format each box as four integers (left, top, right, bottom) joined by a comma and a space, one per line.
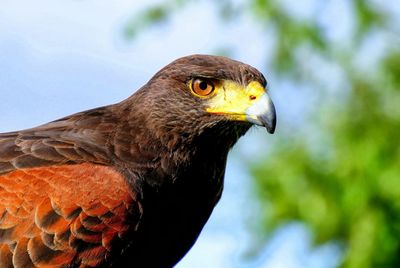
207, 81, 266, 121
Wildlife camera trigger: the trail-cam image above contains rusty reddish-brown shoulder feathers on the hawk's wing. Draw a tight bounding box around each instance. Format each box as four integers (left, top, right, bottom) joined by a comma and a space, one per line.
0, 163, 141, 267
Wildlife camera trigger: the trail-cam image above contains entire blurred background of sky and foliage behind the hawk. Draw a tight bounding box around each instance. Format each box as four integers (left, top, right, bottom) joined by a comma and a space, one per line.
0, 0, 400, 268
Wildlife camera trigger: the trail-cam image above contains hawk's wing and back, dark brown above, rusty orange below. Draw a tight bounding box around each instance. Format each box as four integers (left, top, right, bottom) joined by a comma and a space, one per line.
0, 106, 142, 267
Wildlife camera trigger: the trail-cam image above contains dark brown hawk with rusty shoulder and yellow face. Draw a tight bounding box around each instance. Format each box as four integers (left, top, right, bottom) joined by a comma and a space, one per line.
0, 55, 276, 268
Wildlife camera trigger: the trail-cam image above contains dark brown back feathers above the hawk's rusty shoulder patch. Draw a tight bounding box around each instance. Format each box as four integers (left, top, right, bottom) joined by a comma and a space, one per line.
0, 106, 117, 174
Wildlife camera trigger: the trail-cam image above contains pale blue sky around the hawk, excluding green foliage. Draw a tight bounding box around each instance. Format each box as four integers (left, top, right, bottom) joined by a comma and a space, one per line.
0, 0, 348, 268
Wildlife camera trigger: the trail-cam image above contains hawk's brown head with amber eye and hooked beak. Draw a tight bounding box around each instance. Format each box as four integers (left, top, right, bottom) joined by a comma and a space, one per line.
130, 55, 276, 150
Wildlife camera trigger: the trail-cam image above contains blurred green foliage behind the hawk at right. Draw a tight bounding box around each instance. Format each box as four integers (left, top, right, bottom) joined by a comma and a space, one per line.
128, 0, 400, 268
